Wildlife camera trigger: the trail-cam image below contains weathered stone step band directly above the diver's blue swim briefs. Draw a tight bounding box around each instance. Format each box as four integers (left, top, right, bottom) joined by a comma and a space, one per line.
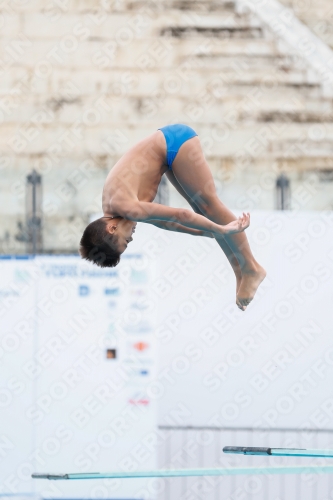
0, 86, 333, 130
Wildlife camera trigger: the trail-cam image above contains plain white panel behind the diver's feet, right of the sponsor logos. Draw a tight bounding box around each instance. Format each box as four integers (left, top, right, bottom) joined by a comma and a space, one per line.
159, 213, 333, 427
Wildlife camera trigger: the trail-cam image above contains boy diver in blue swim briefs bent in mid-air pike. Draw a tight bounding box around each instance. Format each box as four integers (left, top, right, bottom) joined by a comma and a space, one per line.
80, 124, 266, 311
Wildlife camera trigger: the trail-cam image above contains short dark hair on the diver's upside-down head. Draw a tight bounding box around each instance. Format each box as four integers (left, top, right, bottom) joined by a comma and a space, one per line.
80, 218, 121, 267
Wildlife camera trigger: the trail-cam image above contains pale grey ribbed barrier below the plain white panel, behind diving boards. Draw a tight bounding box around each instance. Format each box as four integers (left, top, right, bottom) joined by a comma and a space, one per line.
158, 426, 333, 500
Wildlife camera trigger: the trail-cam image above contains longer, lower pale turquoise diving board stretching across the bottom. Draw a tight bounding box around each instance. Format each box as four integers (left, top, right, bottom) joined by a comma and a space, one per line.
32, 465, 333, 480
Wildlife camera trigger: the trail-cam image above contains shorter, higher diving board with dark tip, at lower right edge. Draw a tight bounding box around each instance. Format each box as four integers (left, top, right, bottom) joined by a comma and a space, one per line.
223, 446, 333, 458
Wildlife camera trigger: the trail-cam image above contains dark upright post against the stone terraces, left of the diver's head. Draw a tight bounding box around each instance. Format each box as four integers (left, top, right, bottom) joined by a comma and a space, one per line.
26, 170, 42, 255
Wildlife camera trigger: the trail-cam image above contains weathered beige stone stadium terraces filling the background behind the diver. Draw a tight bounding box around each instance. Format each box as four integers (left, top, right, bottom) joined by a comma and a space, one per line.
0, 0, 333, 253
